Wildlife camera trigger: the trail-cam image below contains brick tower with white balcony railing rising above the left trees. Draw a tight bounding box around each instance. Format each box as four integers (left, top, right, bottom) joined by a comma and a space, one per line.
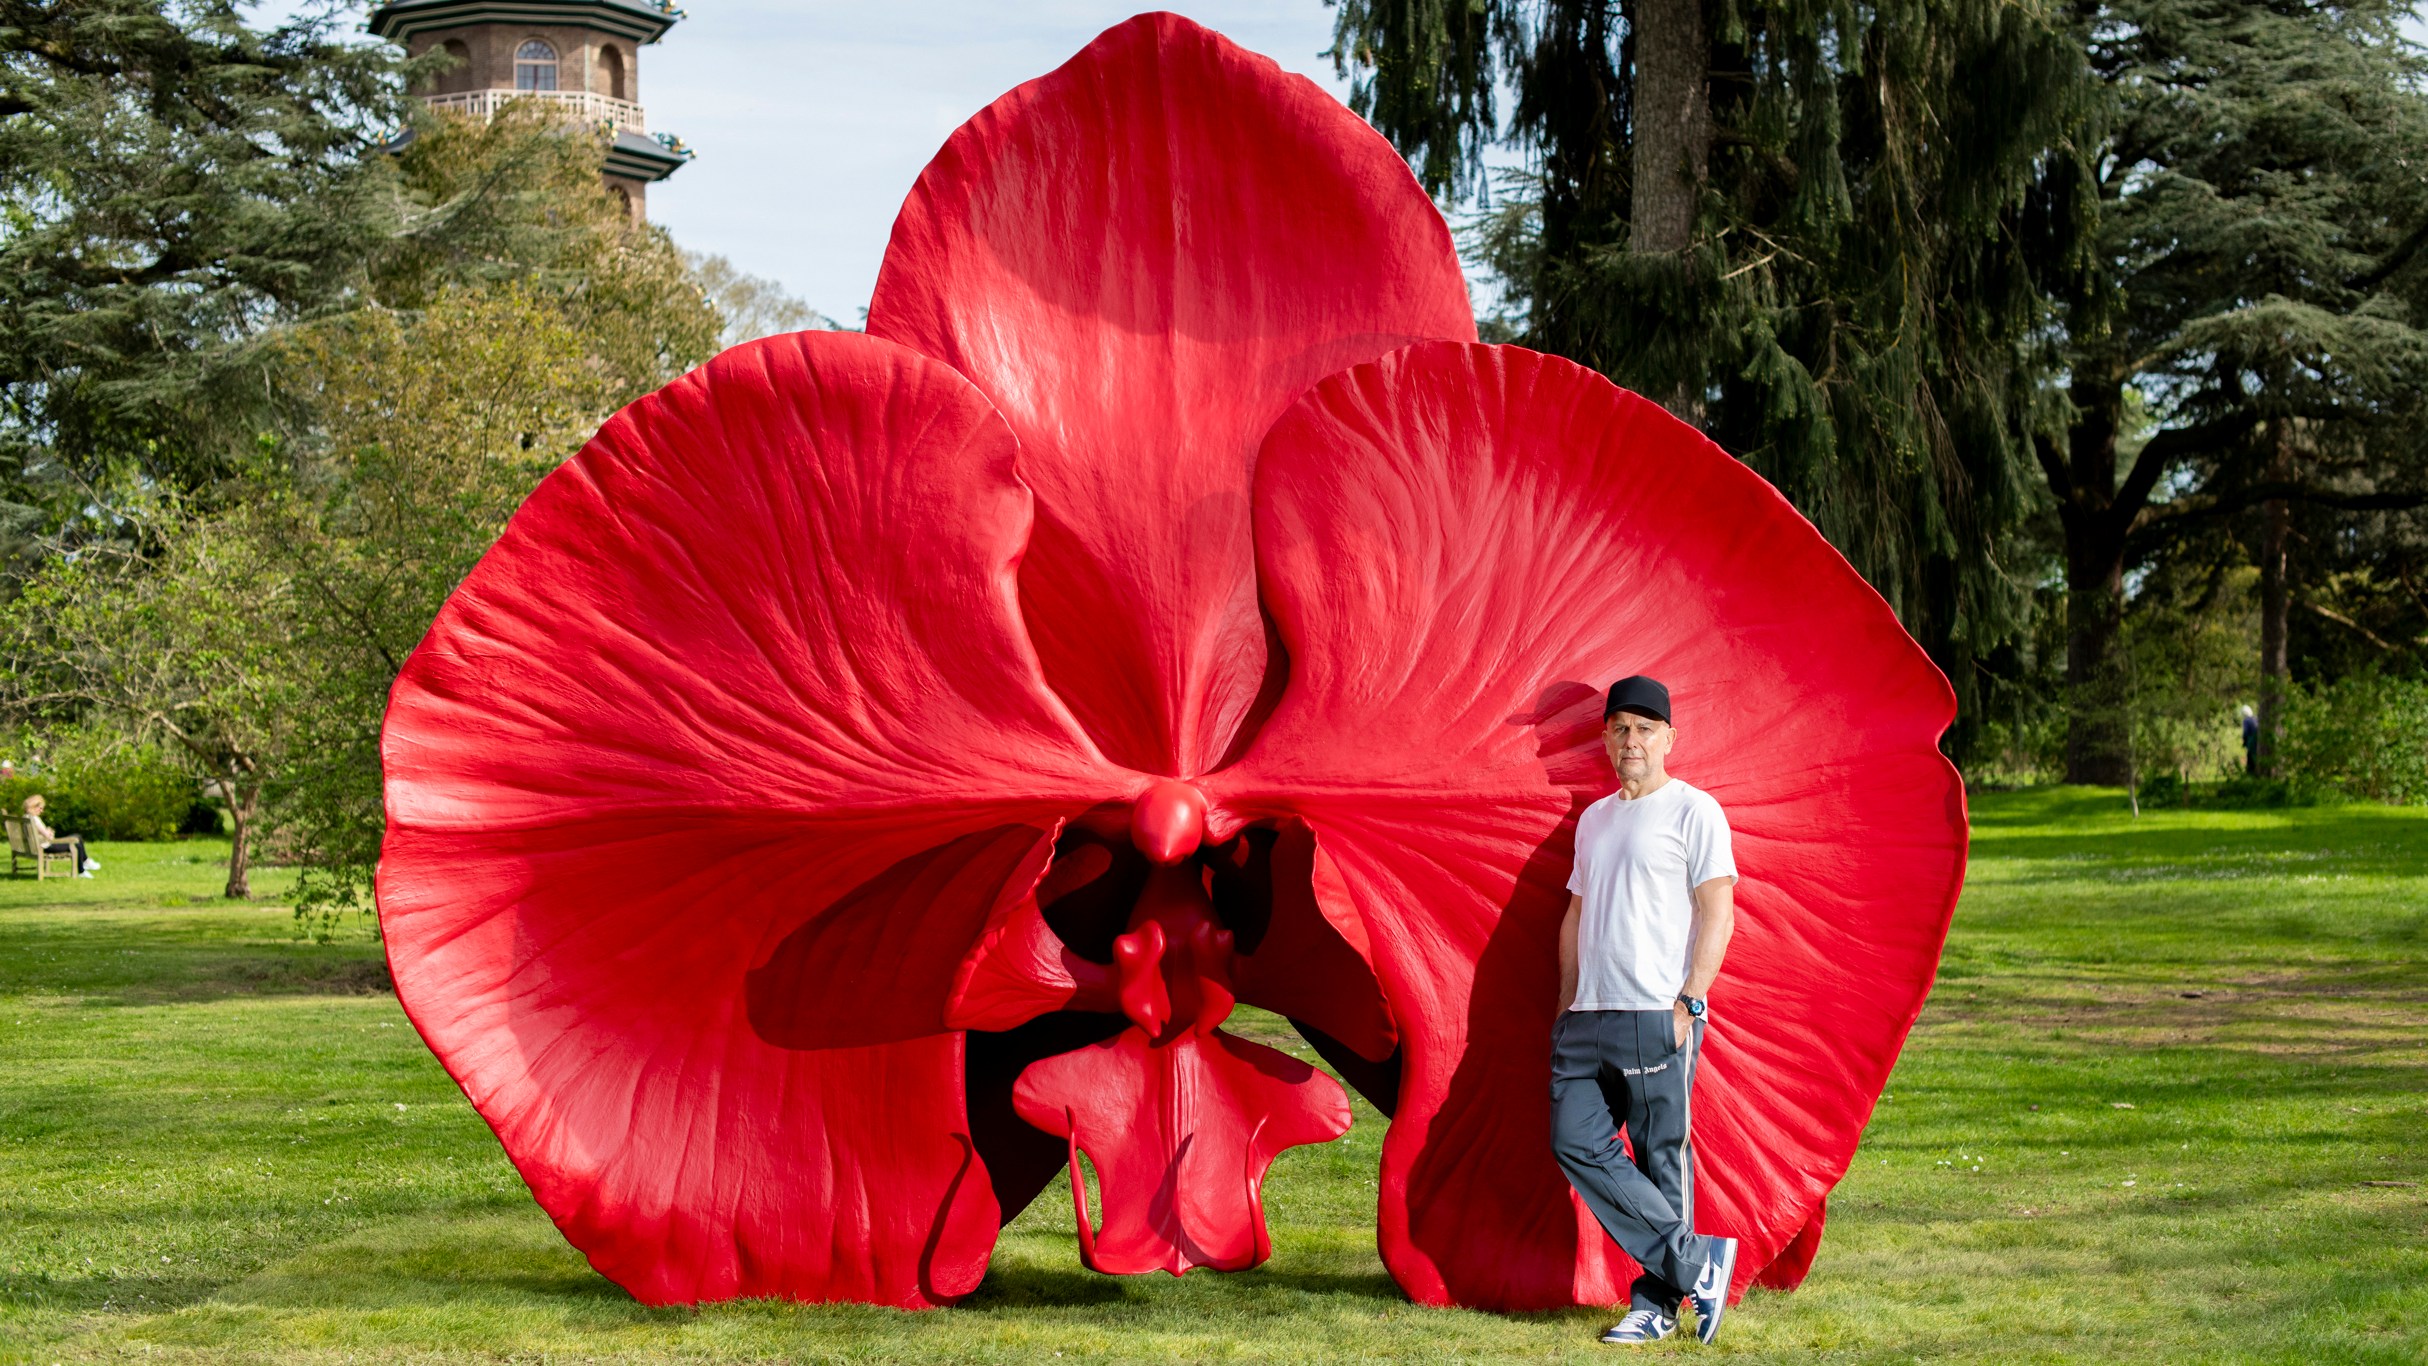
369, 0, 692, 218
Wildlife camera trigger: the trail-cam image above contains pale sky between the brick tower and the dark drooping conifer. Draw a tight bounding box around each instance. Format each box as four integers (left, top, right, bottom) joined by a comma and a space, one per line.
253, 0, 1348, 325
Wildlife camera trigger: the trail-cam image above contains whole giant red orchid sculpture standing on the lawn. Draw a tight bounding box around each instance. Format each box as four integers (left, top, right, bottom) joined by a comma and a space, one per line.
379, 15, 1964, 1308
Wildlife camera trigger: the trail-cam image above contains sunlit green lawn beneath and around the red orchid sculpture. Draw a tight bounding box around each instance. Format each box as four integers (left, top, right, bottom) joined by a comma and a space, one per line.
0, 789, 2428, 1364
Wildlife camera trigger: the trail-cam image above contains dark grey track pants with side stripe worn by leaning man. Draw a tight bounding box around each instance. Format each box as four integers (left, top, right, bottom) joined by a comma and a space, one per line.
1551, 1009, 1712, 1315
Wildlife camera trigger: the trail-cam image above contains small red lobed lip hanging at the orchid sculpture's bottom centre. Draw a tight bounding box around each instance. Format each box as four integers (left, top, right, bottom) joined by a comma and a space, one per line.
1012, 1026, 1350, 1276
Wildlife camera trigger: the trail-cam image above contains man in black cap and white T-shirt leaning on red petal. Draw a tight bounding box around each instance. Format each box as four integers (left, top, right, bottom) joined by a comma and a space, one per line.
1551, 675, 1736, 1342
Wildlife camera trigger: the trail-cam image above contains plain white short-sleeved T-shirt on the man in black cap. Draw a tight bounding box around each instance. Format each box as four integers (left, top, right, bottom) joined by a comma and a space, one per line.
1568, 779, 1736, 1009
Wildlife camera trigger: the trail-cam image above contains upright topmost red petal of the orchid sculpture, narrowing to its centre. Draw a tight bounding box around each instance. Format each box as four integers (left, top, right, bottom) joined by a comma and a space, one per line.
869, 15, 1476, 776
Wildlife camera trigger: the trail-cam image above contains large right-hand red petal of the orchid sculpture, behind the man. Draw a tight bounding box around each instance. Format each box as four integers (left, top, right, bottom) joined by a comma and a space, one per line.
1204, 345, 1964, 1308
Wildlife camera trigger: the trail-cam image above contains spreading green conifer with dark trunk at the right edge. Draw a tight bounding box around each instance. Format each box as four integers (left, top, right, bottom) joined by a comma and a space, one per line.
2032, 0, 2428, 784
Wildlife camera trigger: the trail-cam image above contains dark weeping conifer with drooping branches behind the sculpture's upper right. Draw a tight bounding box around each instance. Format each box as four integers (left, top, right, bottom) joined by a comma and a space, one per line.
1333, 0, 2093, 742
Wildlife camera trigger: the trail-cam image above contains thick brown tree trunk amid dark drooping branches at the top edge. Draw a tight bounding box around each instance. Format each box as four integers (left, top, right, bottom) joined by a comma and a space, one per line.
1629, 0, 1712, 252
